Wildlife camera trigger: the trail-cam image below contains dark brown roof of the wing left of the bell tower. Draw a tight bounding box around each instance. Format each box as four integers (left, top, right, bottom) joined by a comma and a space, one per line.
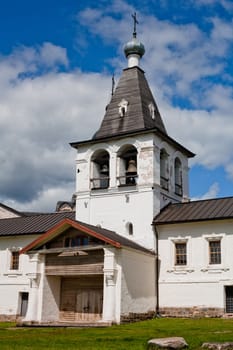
0, 212, 75, 236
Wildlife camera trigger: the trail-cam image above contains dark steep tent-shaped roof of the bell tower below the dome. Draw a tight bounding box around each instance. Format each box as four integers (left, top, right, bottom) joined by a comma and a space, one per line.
93, 67, 167, 139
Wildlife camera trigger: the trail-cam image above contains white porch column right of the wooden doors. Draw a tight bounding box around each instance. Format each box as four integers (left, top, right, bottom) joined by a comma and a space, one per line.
103, 248, 117, 322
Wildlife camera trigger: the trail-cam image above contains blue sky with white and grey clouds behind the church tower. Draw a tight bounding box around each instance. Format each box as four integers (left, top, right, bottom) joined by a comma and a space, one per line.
0, 0, 233, 211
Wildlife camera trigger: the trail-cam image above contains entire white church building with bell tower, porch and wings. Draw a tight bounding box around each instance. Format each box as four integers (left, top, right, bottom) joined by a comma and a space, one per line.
0, 24, 233, 325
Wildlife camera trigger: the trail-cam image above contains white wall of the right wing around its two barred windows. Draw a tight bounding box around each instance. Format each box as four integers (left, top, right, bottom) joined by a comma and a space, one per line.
157, 220, 233, 308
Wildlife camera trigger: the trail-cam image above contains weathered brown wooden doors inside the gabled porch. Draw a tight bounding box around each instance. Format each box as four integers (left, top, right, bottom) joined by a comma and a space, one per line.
60, 276, 103, 322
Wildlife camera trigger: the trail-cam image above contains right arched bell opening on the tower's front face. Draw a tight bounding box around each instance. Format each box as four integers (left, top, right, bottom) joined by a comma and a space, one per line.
117, 145, 138, 186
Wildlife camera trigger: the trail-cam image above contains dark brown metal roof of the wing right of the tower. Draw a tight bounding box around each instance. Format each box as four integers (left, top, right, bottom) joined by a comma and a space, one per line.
153, 197, 233, 225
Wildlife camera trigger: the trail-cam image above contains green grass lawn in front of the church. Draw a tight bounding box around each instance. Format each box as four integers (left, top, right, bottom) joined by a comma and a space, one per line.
0, 318, 233, 350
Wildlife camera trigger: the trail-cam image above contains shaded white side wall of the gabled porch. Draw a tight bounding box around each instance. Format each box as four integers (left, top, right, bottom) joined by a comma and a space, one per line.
119, 249, 156, 316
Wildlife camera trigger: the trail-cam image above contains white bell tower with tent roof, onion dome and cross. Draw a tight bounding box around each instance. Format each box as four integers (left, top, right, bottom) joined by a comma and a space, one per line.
71, 14, 194, 249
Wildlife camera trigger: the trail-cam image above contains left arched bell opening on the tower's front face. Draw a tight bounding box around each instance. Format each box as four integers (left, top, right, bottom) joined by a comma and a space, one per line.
90, 150, 109, 190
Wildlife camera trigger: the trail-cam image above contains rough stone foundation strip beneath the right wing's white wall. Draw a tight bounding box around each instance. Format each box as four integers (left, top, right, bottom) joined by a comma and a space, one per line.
159, 306, 224, 318
